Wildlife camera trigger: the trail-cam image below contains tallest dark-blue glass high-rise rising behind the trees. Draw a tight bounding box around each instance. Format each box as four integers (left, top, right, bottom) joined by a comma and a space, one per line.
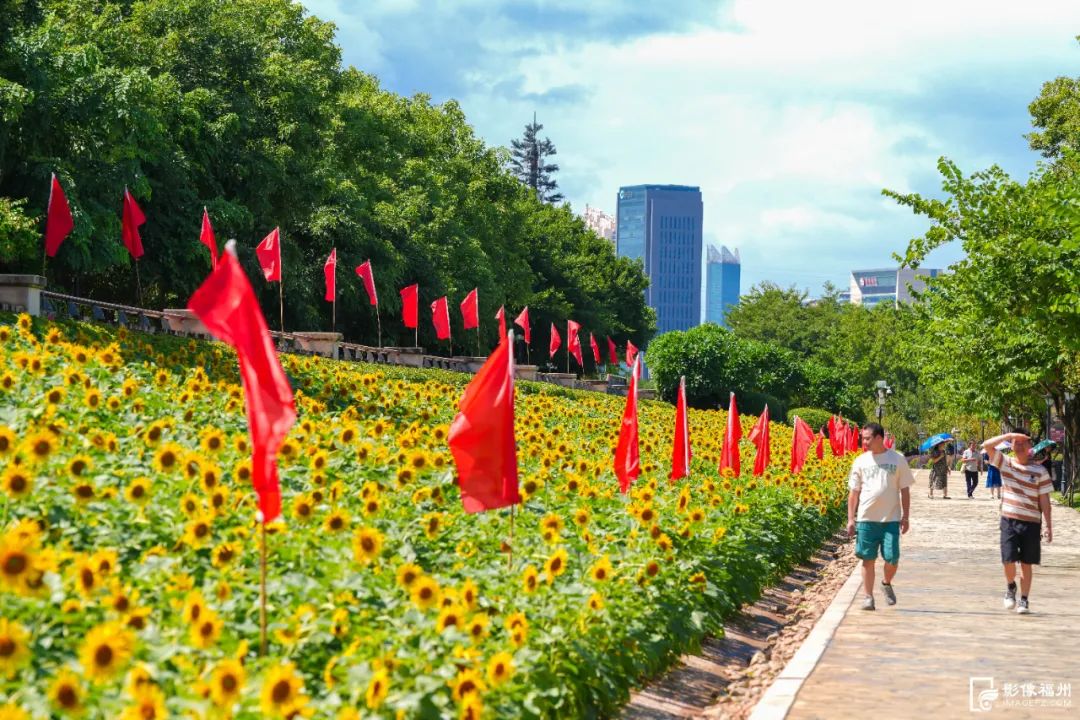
616, 185, 702, 334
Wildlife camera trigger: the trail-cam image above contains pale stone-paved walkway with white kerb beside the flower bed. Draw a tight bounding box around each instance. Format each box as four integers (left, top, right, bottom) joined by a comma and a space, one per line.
754, 471, 1080, 719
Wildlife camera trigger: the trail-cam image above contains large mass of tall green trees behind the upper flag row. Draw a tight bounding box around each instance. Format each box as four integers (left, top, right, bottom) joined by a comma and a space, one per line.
0, 0, 654, 351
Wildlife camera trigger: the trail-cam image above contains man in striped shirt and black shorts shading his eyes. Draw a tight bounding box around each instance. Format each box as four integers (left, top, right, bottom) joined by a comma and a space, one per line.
983, 432, 1054, 614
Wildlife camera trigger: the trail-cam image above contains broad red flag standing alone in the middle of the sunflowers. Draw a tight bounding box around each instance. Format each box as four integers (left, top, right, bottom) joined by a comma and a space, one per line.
448, 335, 522, 513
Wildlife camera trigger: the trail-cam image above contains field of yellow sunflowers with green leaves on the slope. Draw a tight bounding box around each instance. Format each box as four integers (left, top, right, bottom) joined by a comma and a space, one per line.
0, 315, 849, 720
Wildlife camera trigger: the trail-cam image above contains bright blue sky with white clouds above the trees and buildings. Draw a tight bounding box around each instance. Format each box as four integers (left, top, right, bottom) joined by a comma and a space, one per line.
301, 0, 1080, 294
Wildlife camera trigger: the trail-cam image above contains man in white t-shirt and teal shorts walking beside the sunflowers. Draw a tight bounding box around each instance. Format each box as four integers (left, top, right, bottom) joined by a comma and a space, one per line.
848, 422, 915, 610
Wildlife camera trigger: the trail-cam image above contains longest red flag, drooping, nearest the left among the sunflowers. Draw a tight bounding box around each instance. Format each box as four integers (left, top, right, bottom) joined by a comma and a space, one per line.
188, 245, 296, 522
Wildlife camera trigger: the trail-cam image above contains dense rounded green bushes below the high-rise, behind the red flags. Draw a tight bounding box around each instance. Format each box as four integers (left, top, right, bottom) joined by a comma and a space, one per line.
646, 323, 858, 418
